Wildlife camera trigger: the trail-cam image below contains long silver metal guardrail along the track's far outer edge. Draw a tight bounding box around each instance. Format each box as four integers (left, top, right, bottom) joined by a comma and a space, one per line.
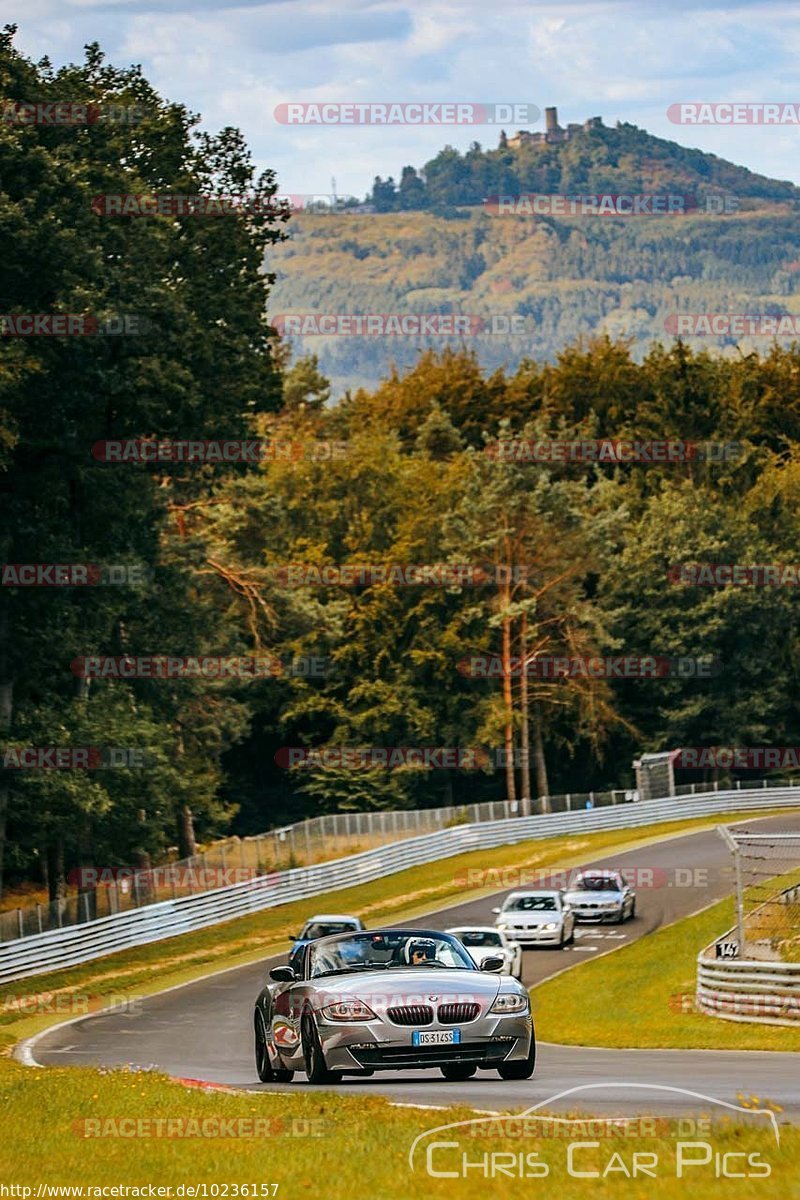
0, 787, 800, 984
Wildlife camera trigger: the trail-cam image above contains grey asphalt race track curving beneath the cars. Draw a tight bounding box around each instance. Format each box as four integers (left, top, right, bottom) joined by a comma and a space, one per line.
32, 812, 800, 1120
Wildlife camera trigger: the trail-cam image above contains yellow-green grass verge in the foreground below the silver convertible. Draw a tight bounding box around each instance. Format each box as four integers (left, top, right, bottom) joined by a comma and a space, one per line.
0, 1068, 800, 1200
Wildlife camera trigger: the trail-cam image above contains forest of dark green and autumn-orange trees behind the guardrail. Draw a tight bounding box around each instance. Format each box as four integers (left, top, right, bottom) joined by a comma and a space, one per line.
0, 30, 800, 895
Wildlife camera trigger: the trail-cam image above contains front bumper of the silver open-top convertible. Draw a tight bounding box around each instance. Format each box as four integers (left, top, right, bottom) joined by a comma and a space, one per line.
318, 1013, 534, 1070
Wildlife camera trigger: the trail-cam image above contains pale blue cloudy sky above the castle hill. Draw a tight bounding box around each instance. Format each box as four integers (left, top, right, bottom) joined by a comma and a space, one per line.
6, 0, 800, 197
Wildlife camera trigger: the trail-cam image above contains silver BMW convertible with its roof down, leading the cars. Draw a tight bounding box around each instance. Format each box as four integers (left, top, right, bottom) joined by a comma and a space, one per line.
254, 929, 536, 1084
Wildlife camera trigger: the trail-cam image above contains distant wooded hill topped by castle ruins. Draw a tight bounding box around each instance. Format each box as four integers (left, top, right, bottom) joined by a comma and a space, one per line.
267, 125, 800, 394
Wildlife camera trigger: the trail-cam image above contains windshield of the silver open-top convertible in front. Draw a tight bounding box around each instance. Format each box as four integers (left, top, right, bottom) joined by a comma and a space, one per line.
308, 930, 475, 978
